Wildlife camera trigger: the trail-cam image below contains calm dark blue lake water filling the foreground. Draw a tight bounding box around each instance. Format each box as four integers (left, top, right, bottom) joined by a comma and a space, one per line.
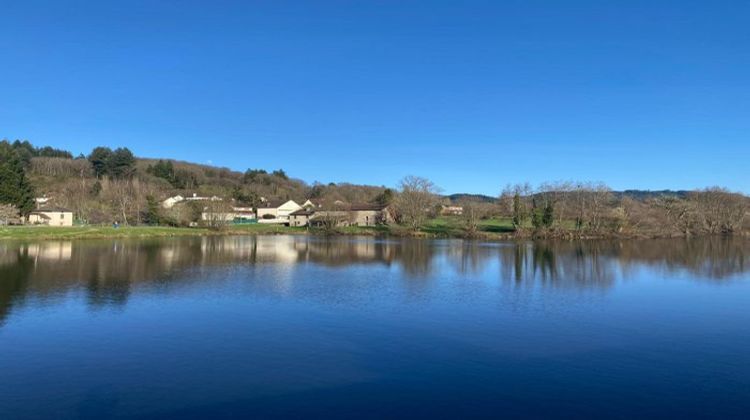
0, 236, 750, 419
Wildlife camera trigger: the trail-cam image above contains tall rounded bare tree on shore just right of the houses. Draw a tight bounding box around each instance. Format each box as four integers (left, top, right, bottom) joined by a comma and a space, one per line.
395, 176, 439, 230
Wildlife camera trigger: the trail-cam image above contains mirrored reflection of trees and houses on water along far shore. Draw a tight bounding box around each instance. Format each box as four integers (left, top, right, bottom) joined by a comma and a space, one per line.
0, 236, 750, 324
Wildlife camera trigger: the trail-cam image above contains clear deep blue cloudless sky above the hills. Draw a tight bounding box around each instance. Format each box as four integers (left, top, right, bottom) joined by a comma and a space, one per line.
0, 0, 750, 195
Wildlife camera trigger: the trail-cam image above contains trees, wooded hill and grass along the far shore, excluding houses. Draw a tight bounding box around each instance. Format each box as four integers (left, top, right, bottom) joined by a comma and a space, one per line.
0, 141, 750, 239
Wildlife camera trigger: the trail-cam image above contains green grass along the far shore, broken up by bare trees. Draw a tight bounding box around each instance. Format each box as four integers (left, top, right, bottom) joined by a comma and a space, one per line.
0, 217, 513, 240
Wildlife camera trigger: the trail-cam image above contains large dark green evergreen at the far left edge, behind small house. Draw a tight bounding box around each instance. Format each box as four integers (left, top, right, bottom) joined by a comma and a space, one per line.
0, 141, 34, 216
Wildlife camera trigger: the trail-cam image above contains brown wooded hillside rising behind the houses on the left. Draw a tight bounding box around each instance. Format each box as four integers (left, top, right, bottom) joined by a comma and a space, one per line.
0, 141, 394, 224
